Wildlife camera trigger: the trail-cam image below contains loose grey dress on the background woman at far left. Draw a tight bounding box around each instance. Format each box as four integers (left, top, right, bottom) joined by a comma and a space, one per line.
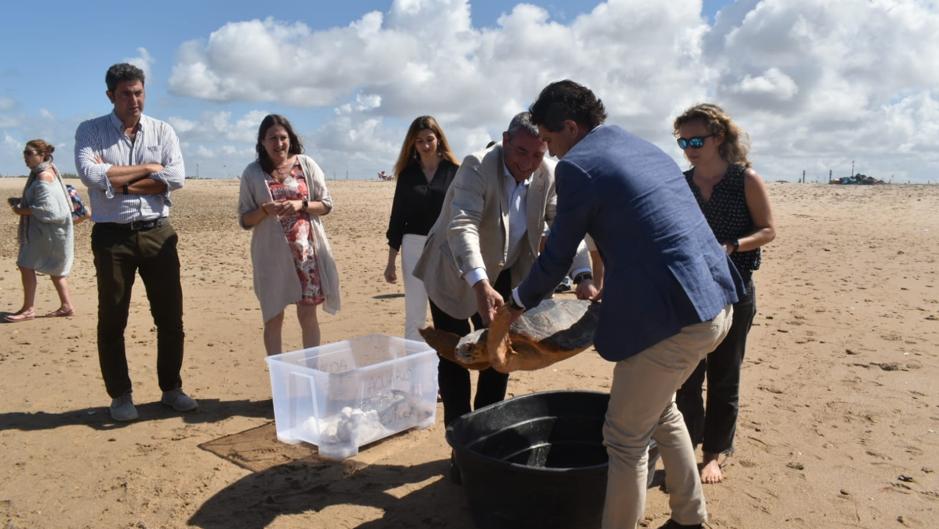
16, 162, 74, 277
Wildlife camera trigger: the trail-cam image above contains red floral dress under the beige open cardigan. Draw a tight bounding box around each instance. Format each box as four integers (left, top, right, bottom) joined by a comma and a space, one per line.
267, 161, 326, 305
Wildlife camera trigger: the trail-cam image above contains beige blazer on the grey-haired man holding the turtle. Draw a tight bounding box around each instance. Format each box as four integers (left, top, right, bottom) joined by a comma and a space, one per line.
414, 143, 589, 319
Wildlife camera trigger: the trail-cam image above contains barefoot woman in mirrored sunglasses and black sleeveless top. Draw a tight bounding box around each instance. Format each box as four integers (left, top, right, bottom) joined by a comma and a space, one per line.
674, 104, 776, 483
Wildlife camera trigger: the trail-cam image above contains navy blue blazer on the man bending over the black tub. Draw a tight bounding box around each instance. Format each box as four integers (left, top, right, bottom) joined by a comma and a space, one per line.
518, 125, 743, 361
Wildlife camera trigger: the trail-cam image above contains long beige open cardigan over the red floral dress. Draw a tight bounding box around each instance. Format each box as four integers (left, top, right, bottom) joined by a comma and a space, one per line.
238, 154, 339, 321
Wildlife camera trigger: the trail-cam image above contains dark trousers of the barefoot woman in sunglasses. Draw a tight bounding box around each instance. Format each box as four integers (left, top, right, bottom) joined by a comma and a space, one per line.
675, 280, 756, 454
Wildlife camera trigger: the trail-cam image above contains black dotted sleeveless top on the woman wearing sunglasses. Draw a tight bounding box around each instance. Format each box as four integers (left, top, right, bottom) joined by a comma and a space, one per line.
685, 164, 760, 281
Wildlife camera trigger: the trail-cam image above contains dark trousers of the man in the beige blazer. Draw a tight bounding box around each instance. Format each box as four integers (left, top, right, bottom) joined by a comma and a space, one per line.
430, 270, 512, 425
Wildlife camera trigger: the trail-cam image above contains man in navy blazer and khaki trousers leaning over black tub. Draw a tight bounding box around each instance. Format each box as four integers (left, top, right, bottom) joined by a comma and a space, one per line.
503, 80, 742, 529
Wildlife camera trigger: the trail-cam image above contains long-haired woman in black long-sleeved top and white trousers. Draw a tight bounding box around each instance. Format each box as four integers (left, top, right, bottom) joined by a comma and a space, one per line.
385, 116, 460, 340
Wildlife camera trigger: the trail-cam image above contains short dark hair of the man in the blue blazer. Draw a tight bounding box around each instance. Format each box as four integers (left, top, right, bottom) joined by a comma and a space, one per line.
528, 79, 606, 132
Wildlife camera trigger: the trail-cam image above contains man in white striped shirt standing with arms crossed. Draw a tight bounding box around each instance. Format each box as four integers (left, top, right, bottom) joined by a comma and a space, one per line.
75, 63, 198, 421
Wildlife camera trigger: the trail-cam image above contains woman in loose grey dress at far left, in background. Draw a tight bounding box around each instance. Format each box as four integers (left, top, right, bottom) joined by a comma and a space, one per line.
5, 140, 74, 322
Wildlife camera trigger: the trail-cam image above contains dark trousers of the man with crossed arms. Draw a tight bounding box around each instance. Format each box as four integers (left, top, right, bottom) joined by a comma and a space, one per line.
91, 223, 184, 398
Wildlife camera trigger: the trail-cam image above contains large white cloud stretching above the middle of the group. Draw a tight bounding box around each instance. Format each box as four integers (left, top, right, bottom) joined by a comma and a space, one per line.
170, 0, 707, 174
